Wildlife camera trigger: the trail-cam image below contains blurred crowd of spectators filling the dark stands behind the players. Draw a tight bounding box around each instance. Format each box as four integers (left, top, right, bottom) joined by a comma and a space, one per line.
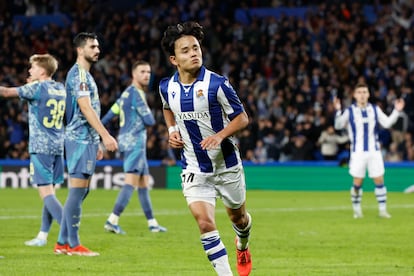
0, 0, 414, 164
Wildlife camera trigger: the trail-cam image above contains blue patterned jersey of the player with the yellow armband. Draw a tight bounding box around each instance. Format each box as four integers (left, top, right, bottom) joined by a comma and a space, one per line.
102, 85, 155, 152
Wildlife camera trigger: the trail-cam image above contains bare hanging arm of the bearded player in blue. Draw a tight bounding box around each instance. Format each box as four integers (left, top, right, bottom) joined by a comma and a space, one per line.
78, 97, 118, 151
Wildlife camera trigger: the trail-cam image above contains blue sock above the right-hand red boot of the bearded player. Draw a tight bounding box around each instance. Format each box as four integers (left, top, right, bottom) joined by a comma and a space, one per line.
63, 188, 88, 247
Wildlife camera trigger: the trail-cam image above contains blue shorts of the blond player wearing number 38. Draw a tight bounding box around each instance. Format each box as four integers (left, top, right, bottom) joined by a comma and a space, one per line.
30, 153, 64, 186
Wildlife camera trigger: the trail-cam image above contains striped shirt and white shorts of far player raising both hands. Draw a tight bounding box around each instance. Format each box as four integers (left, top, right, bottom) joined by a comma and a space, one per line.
335, 104, 399, 178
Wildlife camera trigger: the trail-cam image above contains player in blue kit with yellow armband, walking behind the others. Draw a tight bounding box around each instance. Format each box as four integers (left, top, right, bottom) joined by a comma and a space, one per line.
102, 61, 167, 234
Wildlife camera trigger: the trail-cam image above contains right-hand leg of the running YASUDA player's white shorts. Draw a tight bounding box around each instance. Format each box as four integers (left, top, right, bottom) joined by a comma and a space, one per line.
216, 167, 246, 209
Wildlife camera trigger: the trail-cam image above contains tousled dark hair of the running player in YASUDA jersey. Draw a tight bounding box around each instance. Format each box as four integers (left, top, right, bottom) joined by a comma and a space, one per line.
161, 21, 204, 56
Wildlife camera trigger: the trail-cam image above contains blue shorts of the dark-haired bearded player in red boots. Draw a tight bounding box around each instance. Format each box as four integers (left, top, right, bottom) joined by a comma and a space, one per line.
65, 140, 98, 179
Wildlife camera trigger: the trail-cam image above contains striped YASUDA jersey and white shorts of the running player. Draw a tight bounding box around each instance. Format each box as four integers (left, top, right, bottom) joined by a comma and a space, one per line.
159, 66, 245, 207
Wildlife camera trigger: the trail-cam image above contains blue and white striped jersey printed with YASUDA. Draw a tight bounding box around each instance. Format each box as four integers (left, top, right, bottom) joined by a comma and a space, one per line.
159, 66, 244, 173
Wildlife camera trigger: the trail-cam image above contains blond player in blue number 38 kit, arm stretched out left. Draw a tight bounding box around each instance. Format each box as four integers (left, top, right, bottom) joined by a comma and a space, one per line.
0, 54, 66, 246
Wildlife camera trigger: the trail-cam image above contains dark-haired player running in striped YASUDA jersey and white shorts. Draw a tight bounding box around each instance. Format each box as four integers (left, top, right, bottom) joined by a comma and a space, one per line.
159, 22, 252, 275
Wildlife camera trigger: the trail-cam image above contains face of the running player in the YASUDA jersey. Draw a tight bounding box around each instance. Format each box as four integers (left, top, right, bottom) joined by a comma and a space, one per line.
170, 35, 203, 73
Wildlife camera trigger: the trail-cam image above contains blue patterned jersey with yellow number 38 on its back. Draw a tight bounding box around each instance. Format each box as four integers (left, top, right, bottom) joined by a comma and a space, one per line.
17, 80, 66, 155
